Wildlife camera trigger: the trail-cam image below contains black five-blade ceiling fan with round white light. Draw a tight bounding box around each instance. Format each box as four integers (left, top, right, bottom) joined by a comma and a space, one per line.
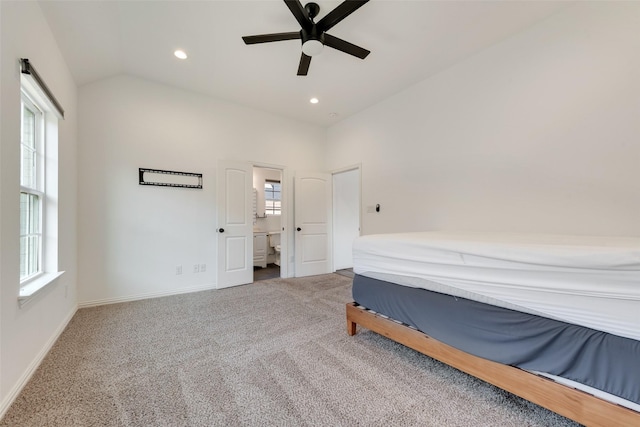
242, 0, 370, 76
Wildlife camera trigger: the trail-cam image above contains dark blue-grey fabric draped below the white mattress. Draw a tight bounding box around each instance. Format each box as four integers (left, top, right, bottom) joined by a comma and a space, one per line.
352, 275, 640, 404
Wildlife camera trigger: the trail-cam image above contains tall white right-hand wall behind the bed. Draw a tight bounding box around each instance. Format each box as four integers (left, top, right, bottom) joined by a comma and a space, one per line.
327, 2, 640, 236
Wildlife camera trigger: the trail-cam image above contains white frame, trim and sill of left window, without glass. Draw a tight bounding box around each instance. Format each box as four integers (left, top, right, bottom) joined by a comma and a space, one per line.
18, 75, 64, 306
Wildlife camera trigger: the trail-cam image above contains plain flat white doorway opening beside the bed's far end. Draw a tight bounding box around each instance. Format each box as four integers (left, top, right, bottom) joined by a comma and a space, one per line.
332, 168, 360, 271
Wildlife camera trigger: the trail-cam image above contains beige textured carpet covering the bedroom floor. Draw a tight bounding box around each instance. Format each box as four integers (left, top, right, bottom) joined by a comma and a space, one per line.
0, 274, 576, 426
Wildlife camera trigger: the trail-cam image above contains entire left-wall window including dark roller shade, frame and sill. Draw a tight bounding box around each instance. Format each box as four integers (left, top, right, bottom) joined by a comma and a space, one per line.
16, 59, 64, 306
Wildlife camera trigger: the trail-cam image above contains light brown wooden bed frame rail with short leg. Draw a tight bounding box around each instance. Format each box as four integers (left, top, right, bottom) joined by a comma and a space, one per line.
347, 303, 640, 427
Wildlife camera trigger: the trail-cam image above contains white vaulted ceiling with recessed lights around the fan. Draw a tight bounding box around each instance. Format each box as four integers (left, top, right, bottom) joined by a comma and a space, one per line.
40, 0, 569, 126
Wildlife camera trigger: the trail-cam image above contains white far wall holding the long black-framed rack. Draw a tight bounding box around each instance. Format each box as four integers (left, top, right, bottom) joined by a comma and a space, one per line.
78, 76, 326, 305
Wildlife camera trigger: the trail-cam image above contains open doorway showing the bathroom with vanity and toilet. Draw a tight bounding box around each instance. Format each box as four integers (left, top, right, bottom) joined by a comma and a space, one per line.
253, 166, 285, 282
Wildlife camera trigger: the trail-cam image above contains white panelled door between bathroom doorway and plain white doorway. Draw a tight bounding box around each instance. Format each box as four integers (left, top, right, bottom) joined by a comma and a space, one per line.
294, 173, 332, 277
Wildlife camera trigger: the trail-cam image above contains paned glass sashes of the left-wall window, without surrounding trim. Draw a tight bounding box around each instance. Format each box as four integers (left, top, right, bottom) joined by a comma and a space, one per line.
20, 93, 45, 283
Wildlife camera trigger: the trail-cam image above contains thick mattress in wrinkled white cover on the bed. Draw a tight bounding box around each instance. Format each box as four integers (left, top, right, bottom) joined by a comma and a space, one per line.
353, 232, 640, 340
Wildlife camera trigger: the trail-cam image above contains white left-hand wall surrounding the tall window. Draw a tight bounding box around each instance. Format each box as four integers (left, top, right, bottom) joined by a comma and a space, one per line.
0, 1, 77, 416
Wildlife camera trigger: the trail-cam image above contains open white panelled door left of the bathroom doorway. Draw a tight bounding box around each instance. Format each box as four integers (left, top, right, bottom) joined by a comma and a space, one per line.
216, 160, 253, 288
